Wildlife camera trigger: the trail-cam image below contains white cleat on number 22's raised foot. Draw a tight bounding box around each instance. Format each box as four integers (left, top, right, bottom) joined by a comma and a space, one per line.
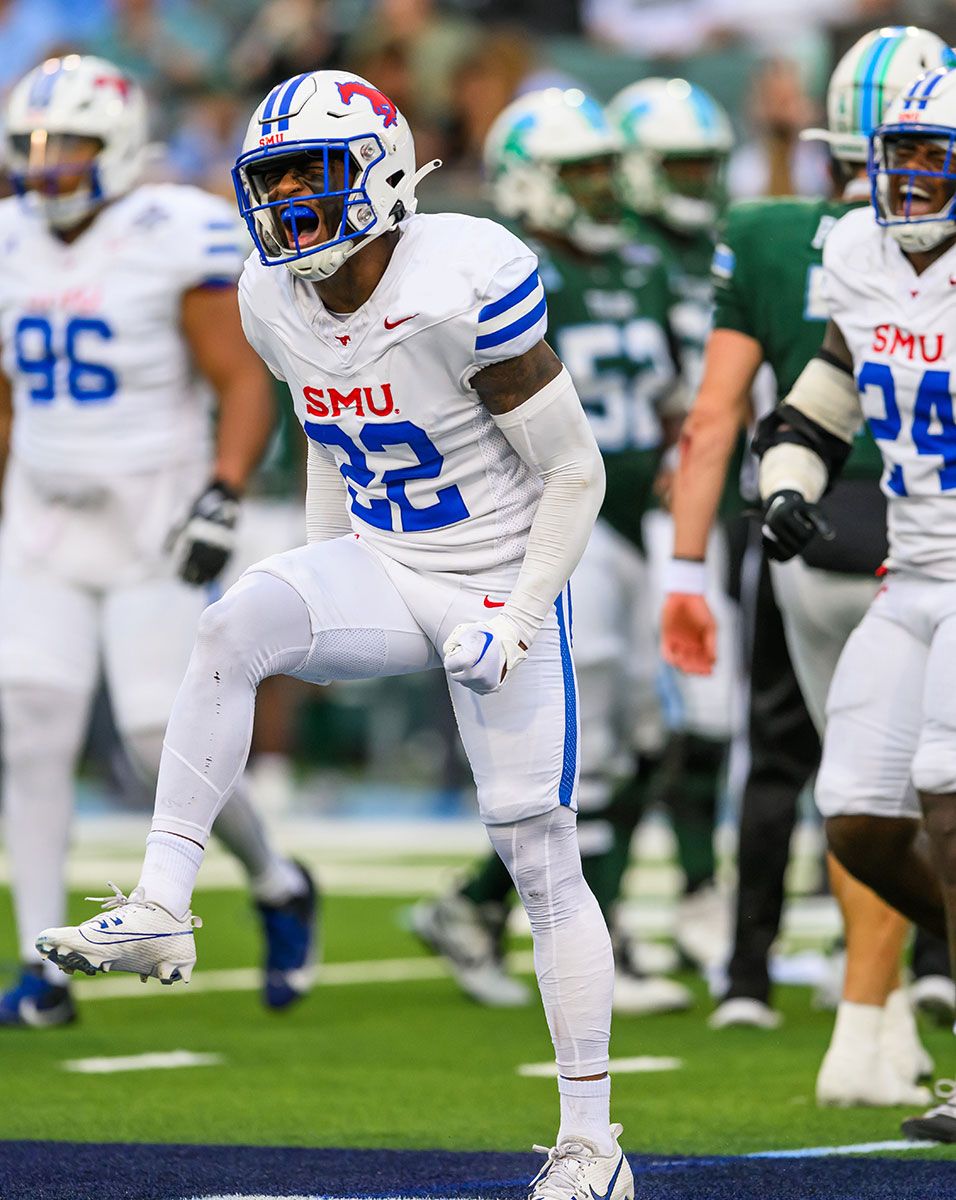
36, 883, 203, 984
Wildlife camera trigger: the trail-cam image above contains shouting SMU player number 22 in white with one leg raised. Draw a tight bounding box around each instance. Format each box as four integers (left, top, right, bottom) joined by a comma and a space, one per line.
38, 71, 633, 1200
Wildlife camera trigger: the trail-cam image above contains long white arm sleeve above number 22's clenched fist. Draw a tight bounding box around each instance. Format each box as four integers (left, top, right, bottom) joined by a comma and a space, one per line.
494, 370, 605, 646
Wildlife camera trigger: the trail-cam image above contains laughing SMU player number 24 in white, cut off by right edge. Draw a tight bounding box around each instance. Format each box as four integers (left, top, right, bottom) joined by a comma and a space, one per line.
757, 67, 956, 1141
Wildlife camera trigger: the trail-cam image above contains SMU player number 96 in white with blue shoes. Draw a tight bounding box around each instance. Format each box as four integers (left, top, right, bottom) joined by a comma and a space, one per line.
0, 55, 312, 1025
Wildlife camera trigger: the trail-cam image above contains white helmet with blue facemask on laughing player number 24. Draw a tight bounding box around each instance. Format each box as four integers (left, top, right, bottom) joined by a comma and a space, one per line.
868, 66, 956, 252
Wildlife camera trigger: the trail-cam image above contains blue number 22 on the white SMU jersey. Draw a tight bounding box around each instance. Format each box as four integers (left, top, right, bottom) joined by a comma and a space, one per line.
305, 421, 469, 533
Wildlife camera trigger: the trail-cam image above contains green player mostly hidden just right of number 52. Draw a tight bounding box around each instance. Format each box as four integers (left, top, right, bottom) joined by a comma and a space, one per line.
607, 78, 742, 968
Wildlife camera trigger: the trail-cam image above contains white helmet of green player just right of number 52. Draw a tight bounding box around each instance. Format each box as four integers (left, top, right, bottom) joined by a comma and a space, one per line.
608, 78, 734, 233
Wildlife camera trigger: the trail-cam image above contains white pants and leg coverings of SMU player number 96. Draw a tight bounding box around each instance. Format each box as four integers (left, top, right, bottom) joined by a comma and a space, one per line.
0, 570, 303, 986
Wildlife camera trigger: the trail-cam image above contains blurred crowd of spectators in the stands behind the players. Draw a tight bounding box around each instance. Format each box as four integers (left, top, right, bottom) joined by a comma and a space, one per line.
0, 0, 956, 211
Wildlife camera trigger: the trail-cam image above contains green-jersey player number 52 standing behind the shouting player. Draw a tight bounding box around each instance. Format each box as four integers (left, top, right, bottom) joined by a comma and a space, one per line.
413, 89, 691, 1013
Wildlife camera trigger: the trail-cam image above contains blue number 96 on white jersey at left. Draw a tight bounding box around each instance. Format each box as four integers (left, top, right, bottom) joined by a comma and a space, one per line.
13, 316, 118, 404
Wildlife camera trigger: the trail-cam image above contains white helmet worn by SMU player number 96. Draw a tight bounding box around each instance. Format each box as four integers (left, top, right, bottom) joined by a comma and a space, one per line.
4, 54, 148, 230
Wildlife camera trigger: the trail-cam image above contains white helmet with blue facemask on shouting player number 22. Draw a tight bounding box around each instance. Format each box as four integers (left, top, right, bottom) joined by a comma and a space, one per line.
233, 71, 441, 280
